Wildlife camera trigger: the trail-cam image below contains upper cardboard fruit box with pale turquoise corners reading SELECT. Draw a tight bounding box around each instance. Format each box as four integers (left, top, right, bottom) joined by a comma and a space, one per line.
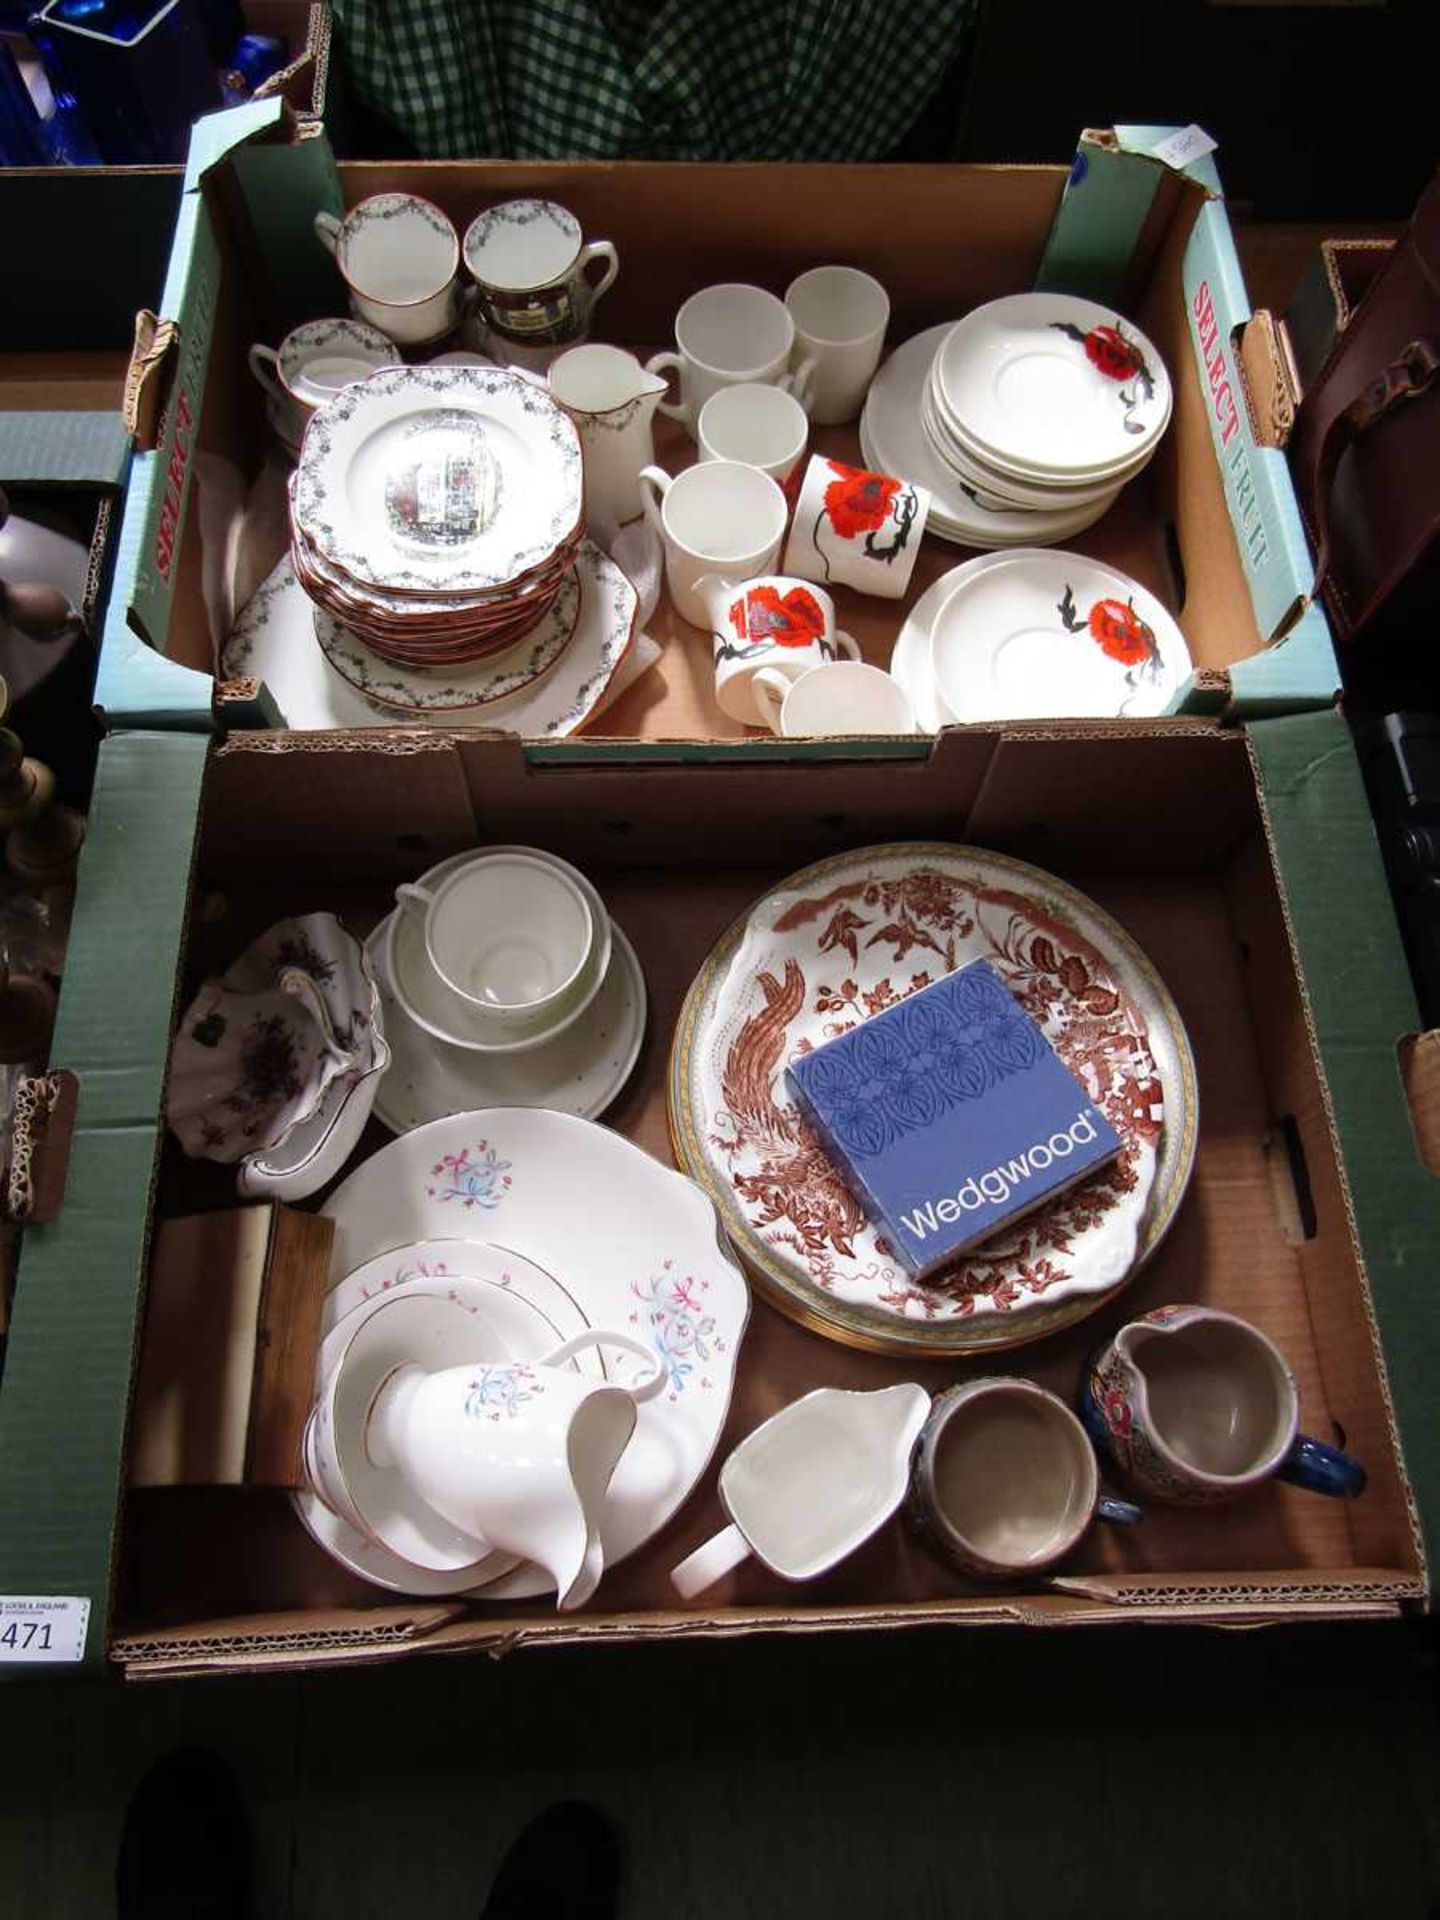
98, 108, 1338, 741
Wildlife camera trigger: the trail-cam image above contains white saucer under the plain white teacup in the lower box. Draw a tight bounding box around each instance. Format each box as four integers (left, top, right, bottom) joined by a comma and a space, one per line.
365, 920, 645, 1133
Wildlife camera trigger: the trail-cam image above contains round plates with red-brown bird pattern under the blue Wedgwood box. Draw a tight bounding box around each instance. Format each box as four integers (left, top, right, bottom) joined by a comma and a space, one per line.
670, 843, 1196, 1354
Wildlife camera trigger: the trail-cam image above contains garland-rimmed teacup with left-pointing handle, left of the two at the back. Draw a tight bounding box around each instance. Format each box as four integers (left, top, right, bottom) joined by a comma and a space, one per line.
315, 194, 461, 346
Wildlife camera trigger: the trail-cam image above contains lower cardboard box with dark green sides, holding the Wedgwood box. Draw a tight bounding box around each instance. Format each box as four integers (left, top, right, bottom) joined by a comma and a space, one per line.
0, 714, 1440, 1676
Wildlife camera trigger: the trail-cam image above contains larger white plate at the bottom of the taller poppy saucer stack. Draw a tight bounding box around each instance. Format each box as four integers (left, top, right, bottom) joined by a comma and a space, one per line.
860, 323, 1110, 547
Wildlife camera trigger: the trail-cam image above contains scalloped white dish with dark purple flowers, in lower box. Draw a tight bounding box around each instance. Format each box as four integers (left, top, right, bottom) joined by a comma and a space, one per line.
167, 914, 390, 1200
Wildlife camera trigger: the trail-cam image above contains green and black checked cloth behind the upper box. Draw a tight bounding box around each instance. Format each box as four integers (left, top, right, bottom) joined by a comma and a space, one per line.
332, 0, 977, 159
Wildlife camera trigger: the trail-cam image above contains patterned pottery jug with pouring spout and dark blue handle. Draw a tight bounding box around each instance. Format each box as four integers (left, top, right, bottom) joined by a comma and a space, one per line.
1081, 1306, 1365, 1507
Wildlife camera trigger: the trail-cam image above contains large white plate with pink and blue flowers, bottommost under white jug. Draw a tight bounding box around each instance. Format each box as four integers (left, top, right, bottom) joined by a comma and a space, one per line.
324, 1108, 749, 1599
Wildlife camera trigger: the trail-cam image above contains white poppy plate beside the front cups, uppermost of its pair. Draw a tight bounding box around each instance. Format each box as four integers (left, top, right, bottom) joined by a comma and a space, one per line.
929, 547, 1190, 722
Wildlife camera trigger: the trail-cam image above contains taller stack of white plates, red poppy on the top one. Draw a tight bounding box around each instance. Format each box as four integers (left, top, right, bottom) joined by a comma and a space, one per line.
860, 294, 1171, 547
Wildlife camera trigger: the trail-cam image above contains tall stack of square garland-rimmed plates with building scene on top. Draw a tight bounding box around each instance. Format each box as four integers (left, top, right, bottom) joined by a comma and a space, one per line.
290, 365, 584, 668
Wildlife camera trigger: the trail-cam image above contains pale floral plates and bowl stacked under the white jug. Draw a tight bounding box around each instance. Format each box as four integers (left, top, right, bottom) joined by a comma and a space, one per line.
303, 1108, 749, 1601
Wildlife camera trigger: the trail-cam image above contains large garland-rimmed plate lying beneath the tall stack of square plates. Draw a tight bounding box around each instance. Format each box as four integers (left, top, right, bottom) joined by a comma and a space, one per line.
221, 540, 639, 739
